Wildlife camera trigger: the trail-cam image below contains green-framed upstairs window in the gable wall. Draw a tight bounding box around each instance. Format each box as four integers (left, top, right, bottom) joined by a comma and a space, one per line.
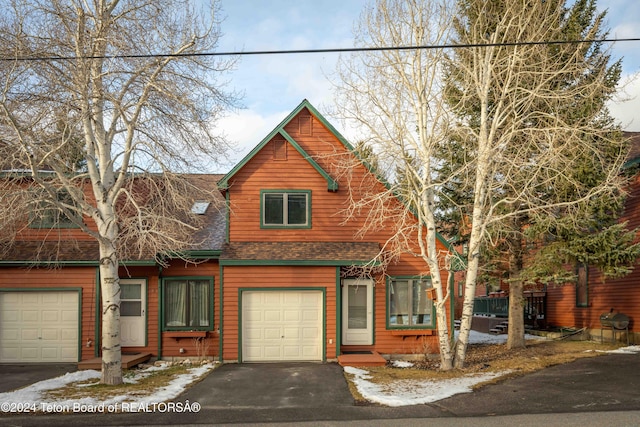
261, 191, 311, 228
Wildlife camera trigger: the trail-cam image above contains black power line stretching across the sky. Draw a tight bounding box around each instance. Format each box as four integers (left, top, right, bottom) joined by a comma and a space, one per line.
0, 38, 640, 61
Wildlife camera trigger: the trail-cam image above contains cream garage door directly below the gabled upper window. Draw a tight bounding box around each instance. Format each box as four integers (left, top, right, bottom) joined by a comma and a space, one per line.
242, 291, 323, 362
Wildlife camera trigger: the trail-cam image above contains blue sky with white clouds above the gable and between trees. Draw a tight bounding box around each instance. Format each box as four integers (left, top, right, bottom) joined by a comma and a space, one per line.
214, 0, 640, 172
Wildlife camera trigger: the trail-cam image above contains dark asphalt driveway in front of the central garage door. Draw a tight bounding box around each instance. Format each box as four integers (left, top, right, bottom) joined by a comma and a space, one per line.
180, 363, 354, 410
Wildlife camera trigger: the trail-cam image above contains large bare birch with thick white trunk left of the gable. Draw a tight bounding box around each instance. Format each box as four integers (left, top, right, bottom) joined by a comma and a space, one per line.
0, 0, 236, 384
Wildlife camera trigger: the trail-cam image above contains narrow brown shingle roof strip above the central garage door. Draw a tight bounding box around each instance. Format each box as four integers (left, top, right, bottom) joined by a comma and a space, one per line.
220, 242, 380, 265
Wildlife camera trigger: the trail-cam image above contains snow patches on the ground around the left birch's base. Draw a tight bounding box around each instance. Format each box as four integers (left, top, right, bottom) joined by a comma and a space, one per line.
0, 364, 215, 412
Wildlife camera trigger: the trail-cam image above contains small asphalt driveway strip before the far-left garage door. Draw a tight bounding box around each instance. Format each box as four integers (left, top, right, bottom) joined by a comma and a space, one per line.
0, 363, 78, 393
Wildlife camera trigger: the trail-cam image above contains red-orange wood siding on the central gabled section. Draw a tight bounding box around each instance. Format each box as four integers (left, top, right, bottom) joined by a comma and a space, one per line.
223, 109, 456, 360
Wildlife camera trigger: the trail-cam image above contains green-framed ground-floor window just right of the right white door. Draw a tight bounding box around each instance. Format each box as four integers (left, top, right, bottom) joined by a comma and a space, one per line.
387, 278, 435, 328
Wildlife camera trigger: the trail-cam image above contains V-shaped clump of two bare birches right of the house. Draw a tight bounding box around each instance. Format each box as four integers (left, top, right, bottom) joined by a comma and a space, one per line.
336, 0, 626, 369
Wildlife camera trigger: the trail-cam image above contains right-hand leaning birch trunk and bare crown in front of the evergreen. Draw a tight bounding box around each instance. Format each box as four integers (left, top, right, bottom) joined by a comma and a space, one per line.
447, 0, 626, 366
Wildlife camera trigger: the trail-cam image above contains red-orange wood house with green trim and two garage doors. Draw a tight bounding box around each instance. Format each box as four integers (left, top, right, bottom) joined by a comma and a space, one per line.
0, 100, 460, 363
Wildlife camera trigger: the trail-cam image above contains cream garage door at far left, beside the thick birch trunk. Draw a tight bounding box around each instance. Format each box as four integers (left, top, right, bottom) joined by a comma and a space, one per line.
0, 291, 78, 363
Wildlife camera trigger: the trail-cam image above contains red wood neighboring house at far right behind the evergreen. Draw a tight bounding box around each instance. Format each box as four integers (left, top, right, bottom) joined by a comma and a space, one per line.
546, 132, 640, 342
